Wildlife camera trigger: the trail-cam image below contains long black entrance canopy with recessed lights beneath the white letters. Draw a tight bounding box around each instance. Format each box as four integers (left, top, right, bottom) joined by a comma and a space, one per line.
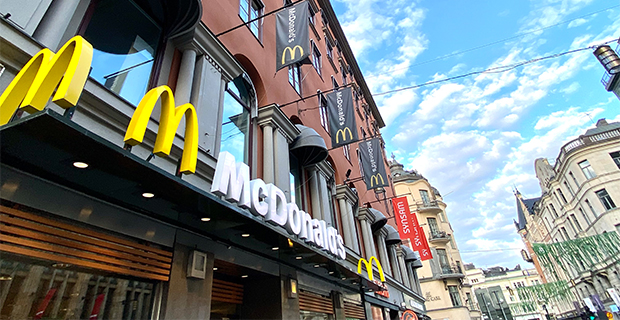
0, 109, 379, 291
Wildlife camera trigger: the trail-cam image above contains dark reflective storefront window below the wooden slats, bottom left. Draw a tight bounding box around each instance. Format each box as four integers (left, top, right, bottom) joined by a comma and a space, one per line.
0, 260, 155, 319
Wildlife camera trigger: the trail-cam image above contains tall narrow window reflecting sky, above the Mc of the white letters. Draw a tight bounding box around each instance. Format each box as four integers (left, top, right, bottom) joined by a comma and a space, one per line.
220, 82, 250, 163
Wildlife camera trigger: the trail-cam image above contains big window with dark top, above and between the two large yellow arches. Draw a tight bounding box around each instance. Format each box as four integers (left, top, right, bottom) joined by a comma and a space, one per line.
84, 0, 162, 105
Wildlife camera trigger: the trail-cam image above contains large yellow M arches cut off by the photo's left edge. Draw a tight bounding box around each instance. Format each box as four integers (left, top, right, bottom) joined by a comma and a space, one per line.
0, 36, 93, 125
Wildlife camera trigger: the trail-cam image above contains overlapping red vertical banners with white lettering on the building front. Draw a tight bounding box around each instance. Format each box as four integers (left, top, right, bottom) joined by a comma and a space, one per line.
392, 197, 433, 261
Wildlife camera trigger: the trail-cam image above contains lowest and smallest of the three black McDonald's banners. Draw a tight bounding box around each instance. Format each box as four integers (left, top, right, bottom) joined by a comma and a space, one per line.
359, 138, 390, 190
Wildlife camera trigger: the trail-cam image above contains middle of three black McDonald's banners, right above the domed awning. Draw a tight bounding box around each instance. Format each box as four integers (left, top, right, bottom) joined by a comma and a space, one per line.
326, 87, 358, 148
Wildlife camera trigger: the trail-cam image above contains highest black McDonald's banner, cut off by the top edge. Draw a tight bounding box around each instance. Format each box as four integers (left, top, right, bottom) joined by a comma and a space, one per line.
276, 1, 310, 71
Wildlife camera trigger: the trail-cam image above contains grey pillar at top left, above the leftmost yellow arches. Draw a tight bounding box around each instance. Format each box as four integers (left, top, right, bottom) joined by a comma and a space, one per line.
33, 0, 80, 52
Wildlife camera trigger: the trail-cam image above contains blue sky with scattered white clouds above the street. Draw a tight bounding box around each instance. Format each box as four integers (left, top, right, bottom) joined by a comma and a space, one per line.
332, 0, 620, 267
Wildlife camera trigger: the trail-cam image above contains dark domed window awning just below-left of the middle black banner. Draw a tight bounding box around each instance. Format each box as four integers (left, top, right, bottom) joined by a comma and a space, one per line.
290, 124, 328, 167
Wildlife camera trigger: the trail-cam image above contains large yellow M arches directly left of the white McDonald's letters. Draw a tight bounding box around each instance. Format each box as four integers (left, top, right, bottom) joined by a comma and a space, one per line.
125, 86, 198, 173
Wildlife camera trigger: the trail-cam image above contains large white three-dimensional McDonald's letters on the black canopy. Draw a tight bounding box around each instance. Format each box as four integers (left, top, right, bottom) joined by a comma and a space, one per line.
211, 151, 347, 259
